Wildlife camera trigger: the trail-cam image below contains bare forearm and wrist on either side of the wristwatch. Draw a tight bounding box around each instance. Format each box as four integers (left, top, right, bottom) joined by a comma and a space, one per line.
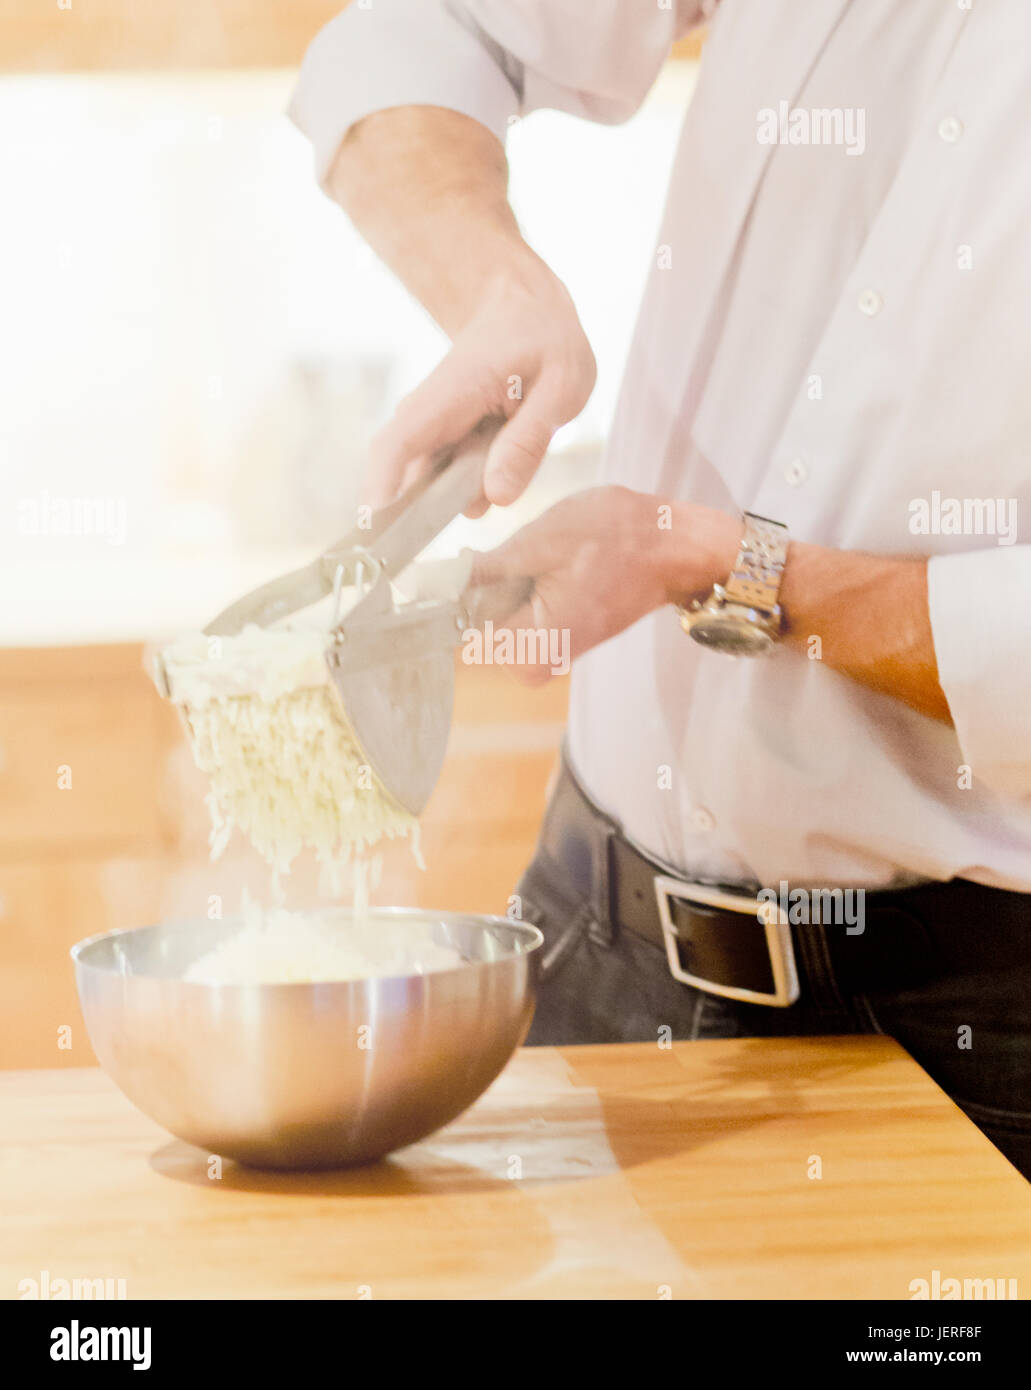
671, 505, 952, 723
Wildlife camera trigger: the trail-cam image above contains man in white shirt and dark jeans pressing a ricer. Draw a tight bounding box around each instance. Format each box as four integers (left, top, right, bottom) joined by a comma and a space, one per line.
292, 0, 1031, 1175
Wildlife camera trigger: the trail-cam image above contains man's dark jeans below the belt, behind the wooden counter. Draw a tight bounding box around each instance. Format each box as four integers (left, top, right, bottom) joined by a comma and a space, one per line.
517, 767, 1031, 1179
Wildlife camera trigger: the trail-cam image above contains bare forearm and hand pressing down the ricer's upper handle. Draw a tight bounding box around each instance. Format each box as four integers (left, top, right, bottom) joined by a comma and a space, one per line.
329, 107, 595, 516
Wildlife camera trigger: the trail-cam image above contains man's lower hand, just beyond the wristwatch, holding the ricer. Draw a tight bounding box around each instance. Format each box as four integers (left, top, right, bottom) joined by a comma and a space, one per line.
471, 487, 741, 685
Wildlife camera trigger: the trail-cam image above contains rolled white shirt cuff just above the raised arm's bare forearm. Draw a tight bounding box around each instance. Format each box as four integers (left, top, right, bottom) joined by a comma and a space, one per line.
288, 0, 520, 185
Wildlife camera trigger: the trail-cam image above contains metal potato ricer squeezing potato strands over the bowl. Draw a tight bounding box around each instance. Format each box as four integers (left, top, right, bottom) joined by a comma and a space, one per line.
151, 420, 532, 816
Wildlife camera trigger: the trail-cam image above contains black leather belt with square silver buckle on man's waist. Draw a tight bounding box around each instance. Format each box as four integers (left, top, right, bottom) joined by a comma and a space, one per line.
538, 760, 1031, 1006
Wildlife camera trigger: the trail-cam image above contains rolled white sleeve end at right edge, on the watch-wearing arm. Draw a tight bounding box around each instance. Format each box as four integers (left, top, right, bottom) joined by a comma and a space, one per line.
927, 545, 1031, 798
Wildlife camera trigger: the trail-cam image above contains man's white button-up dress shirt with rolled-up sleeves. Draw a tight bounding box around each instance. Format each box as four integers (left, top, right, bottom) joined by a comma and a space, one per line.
292, 0, 1031, 891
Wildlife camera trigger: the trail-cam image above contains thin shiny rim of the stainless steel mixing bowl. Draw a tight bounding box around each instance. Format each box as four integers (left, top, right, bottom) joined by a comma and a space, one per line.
68, 904, 545, 990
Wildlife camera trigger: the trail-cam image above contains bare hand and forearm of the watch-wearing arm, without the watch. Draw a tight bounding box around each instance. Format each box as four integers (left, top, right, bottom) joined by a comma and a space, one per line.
472, 487, 952, 724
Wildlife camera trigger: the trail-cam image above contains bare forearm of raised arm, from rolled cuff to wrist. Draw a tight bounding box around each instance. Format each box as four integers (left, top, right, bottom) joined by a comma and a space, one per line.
328, 106, 545, 338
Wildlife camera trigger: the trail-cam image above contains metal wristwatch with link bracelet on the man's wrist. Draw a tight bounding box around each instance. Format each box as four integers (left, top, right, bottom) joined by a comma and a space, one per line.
677, 512, 789, 656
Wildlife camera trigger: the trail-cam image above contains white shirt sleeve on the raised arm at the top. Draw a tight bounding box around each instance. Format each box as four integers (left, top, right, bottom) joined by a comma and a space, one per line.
289, 0, 718, 183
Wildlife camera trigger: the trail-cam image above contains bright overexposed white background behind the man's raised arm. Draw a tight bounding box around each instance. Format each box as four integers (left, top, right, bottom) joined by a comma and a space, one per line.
0, 61, 695, 645
